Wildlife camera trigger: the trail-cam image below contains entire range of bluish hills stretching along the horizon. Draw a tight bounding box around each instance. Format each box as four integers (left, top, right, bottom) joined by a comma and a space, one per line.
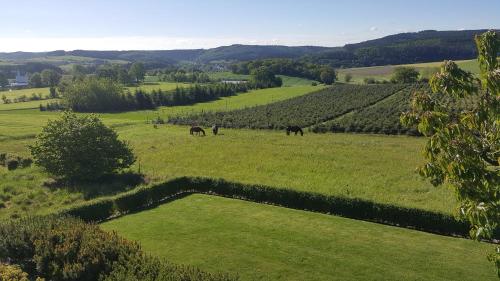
0, 30, 494, 68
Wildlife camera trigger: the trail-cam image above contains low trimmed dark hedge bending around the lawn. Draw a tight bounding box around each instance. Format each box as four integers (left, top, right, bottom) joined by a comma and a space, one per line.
57, 177, 500, 238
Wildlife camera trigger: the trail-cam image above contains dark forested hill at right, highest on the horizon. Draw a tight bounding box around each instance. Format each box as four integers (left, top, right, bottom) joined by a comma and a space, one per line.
304, 30, 487, 67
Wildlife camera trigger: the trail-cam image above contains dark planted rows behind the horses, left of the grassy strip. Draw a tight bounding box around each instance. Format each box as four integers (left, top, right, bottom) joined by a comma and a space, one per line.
169, 84, 406, 129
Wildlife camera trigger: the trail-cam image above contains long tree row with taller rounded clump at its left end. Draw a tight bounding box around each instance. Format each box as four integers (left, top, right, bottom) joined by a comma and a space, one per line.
49, 77, 248, 112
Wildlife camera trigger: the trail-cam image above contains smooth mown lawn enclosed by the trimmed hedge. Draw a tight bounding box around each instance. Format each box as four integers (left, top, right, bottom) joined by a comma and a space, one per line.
101, 195, 496, 281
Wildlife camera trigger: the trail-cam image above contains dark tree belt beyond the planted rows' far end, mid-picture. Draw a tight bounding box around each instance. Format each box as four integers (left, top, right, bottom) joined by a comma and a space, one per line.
230, 59, 337, 84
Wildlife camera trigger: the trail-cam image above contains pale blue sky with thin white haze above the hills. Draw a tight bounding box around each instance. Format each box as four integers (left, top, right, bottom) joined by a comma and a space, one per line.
0, 0, 500, 52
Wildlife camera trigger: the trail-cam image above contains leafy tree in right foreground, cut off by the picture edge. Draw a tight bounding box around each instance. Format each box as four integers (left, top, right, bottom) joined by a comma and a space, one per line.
401, 31, 500, 277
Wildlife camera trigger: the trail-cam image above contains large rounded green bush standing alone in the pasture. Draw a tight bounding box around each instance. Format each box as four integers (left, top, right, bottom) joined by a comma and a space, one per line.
29, 112, 135, 181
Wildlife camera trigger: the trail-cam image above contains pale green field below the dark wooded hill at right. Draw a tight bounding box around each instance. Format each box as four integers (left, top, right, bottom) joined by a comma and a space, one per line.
337, 60, 479, 83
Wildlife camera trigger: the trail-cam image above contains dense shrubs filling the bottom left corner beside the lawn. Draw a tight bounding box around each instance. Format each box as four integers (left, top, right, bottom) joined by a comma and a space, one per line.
0, 216, 234, 281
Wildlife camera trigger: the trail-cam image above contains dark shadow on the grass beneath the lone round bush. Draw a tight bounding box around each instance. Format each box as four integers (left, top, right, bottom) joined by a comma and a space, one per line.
44, 172, 147, 200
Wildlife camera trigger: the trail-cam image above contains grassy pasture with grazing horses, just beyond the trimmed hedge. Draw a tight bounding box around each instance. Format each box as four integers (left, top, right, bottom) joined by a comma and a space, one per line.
0, 118, 456, 217
